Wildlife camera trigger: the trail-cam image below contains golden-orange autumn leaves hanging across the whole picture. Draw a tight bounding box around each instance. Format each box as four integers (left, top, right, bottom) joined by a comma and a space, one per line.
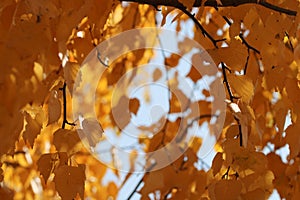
0, 0, 300, 200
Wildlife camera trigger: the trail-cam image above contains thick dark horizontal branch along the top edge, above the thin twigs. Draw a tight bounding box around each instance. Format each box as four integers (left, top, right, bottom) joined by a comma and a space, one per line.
119, 0, 297, 16
